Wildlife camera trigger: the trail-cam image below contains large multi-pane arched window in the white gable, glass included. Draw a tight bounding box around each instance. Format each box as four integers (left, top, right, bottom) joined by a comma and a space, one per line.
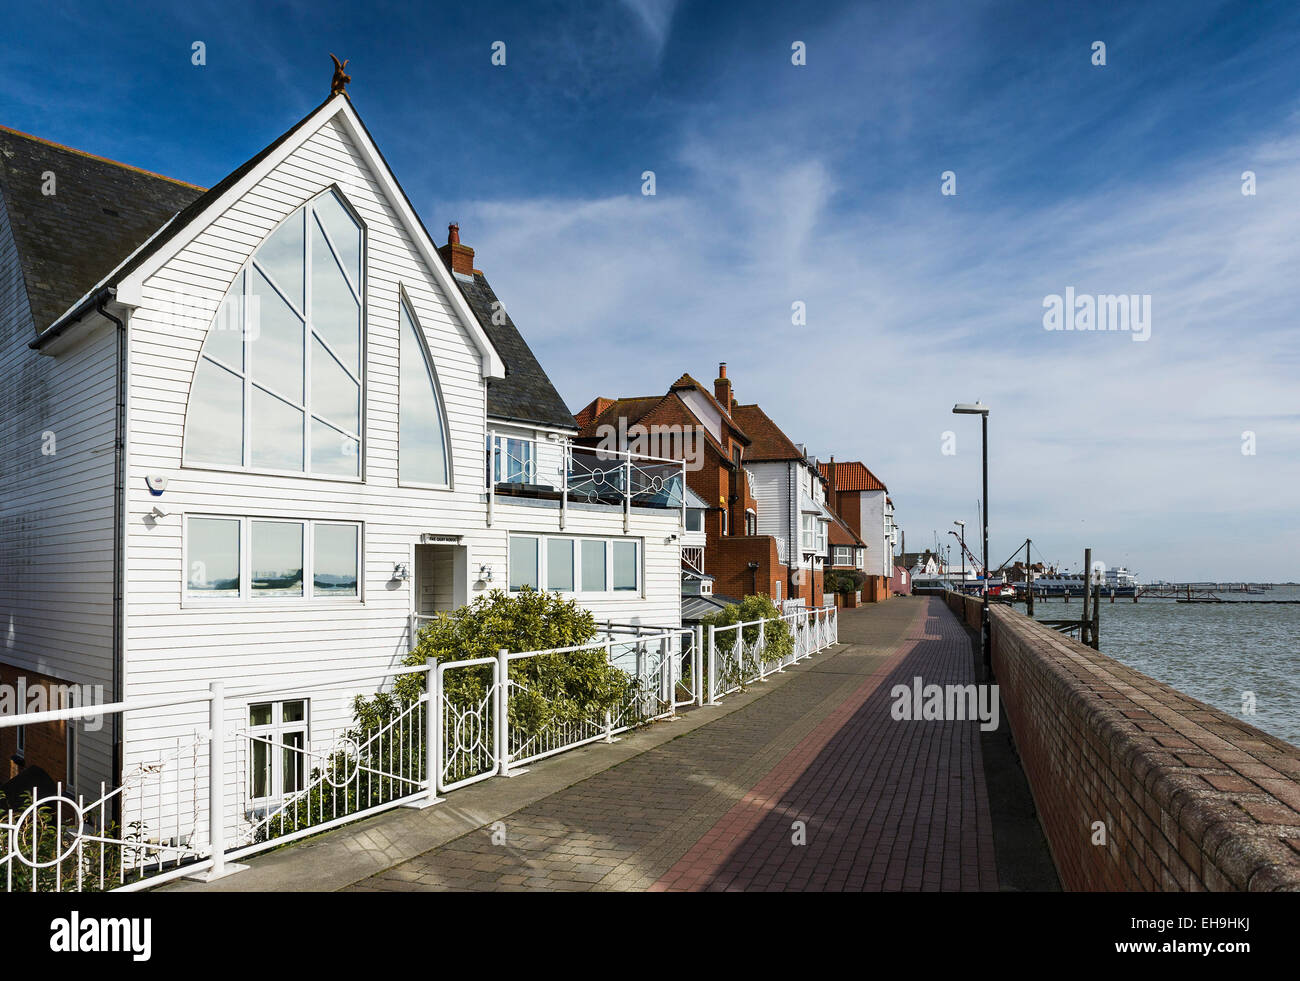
185, 190, 364, 477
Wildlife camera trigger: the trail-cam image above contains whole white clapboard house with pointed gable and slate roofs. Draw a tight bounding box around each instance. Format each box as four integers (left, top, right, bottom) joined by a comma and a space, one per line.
0, 95, 684, 815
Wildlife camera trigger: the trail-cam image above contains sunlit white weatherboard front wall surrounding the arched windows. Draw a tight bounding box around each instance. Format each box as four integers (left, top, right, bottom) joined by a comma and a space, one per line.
114, 111, 680, 831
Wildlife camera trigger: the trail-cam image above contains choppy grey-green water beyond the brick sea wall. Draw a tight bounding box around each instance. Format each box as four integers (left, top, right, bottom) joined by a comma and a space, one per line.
1022, 586, 1300, 746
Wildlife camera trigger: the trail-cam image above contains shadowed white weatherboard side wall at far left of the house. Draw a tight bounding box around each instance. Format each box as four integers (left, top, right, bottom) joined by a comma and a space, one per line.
0, 196, 117, 786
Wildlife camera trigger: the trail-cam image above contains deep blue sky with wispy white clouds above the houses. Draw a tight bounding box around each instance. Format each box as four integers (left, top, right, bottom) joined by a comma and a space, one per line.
0, 0, 1300, 580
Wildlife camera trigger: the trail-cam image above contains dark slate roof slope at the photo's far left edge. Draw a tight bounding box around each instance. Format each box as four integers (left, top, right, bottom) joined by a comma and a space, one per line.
0, 126, 203, 333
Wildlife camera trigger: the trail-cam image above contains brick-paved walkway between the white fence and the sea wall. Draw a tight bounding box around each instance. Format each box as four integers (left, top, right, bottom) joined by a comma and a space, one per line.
354, 596, 997, 890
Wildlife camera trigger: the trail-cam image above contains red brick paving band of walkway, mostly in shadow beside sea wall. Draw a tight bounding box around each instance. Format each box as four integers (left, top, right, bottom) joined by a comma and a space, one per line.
651, 600, 997, 891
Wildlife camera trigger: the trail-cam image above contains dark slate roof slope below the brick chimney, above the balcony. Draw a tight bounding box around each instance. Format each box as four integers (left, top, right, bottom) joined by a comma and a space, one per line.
452, 272, 579, 429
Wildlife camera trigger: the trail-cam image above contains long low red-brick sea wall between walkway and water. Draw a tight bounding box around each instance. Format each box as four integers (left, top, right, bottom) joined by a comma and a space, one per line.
946, 592, 1300, 891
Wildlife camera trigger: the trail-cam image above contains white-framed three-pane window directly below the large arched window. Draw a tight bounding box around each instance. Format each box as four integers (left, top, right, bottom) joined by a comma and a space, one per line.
181, 512, 365, 605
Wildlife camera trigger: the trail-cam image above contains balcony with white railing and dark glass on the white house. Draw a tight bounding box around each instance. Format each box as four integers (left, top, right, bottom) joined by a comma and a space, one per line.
486, 431, 686, 529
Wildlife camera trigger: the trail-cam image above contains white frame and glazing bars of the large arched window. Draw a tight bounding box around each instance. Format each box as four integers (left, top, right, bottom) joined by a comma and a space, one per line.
181, 183, 369, 483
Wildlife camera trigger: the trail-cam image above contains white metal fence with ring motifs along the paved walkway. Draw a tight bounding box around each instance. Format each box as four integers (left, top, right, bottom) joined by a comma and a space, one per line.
0, 608, 839, 891
